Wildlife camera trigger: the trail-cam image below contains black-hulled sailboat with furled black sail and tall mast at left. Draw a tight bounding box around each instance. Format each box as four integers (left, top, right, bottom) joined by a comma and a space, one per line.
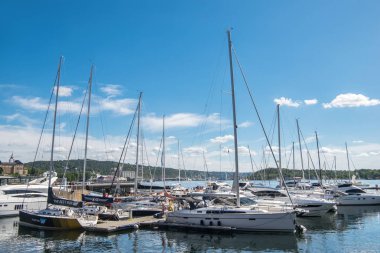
19, 57, 98, 230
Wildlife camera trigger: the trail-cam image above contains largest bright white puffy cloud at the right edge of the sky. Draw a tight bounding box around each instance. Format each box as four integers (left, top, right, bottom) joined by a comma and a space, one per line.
323, 93, 380, 109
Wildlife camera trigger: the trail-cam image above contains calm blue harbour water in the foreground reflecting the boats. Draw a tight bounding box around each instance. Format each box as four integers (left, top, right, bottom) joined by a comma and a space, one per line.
0, 181, 380, 253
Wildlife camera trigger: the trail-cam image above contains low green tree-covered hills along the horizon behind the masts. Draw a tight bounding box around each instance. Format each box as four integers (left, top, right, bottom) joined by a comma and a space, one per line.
25, 160, 380, 181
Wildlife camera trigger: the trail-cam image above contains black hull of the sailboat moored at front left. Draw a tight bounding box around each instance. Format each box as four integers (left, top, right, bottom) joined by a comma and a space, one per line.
19, 211, 89, 230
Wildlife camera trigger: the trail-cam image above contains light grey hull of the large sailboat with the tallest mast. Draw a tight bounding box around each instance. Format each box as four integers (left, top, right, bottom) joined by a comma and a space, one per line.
166, 208, 296, 233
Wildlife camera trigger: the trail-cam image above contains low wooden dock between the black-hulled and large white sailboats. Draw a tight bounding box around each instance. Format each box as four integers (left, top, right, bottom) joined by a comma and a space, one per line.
83, 216, 163, 233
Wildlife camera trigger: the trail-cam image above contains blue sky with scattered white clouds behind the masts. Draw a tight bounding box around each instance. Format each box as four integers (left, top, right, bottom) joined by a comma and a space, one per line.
0, 0, 380, 174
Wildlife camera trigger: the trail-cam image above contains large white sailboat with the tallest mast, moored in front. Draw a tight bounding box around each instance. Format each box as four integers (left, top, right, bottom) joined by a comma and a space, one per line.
162, 30, 302, 232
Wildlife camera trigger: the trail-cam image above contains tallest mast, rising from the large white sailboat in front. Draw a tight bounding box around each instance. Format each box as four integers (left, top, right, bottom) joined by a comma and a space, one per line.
227, 30, 240, 207
